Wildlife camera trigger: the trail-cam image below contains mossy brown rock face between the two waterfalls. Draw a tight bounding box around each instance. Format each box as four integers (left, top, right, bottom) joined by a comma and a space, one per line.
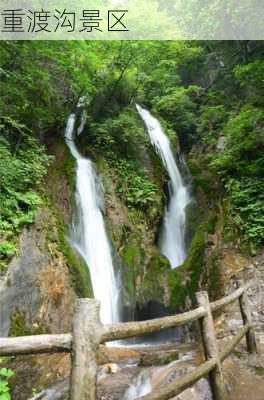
97, 155, 170, 320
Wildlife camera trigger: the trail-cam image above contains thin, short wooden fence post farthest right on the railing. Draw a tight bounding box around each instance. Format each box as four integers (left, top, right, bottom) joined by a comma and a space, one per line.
236, 279, 257, 354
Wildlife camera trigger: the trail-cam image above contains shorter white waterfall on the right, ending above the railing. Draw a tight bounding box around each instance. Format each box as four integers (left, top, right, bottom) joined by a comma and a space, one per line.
137, 105, 191, 268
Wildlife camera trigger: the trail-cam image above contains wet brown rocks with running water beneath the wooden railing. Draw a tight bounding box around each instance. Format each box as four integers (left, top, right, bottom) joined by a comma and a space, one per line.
98, 347, 212, 400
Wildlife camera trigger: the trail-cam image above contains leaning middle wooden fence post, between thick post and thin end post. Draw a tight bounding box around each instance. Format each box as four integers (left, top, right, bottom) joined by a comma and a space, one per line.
196, 291, 226, 400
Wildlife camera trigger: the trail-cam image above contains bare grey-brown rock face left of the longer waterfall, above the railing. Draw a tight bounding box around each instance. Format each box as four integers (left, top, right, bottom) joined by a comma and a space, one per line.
0, 209, 75, 336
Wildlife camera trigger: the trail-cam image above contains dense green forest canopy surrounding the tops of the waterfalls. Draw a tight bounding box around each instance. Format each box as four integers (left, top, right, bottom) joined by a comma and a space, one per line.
0, 41, 264, 268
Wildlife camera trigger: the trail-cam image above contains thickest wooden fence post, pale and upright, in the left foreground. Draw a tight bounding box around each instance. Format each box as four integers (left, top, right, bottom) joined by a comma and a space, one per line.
71, 299, 102, 400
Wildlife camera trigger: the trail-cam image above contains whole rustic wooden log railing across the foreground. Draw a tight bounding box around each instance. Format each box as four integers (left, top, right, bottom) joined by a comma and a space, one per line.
0, 281, 256, 400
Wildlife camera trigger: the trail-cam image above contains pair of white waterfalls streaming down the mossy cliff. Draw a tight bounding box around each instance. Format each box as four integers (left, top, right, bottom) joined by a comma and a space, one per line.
65, 105, 190, 324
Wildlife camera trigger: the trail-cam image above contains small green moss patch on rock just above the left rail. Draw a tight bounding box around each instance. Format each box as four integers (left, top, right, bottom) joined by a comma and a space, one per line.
9, 310, 49, 336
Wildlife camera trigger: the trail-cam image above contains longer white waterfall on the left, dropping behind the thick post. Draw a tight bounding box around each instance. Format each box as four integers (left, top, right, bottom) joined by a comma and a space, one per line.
65, 114, 119, 324
